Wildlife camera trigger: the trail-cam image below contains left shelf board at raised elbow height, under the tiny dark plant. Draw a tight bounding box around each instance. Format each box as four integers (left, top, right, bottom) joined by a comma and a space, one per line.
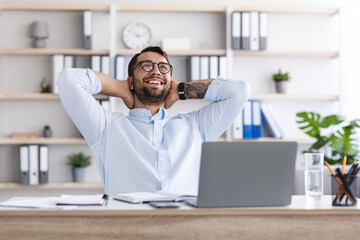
0, 93, 109, 100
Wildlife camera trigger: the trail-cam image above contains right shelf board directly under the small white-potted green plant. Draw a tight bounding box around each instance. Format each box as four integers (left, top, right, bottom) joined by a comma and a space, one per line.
250, 93, 339, 101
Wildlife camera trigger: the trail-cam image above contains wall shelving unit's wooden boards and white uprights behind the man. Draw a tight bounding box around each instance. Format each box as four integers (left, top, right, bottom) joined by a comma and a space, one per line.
0, 4, 340, 194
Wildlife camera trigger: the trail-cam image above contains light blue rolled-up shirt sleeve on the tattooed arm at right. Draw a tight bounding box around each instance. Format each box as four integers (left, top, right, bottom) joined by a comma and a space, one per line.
195, 77, 250, 141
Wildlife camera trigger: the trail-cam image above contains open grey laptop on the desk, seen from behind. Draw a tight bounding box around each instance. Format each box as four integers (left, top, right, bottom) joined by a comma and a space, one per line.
186, 141, 297, 208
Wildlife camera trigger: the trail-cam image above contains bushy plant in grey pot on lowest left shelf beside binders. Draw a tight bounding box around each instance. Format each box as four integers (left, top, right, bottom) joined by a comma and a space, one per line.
68, 152, 91, 182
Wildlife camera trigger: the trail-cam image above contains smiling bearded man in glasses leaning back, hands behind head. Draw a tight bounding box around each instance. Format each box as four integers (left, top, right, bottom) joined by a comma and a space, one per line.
58, 47, 250, 196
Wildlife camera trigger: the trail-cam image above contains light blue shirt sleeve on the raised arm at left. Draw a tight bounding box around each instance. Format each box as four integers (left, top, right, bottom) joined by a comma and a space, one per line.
58, 68, 107, 147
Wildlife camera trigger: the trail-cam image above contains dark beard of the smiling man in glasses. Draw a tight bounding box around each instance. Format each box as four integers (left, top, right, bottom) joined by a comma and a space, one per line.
133, 78, 170, 106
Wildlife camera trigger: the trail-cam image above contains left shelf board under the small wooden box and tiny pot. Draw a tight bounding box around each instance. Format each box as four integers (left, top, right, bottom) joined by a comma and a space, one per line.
0, 137, 86, 145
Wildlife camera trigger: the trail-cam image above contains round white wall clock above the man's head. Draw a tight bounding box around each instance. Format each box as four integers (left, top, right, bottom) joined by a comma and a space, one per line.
123, 22, 151, 49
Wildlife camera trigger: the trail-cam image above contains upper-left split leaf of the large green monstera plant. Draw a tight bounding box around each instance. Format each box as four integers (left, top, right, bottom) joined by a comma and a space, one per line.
296, 112, 321, 138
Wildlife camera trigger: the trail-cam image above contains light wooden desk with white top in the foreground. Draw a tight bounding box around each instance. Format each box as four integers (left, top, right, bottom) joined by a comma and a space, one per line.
0, 196, 360, 240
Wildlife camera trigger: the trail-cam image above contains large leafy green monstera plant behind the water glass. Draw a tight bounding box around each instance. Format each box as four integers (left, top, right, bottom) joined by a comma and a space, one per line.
296, 112, 360, 164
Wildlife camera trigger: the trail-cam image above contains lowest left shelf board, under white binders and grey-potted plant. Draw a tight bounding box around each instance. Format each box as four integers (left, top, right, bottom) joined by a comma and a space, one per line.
0, 182, 103, 190
